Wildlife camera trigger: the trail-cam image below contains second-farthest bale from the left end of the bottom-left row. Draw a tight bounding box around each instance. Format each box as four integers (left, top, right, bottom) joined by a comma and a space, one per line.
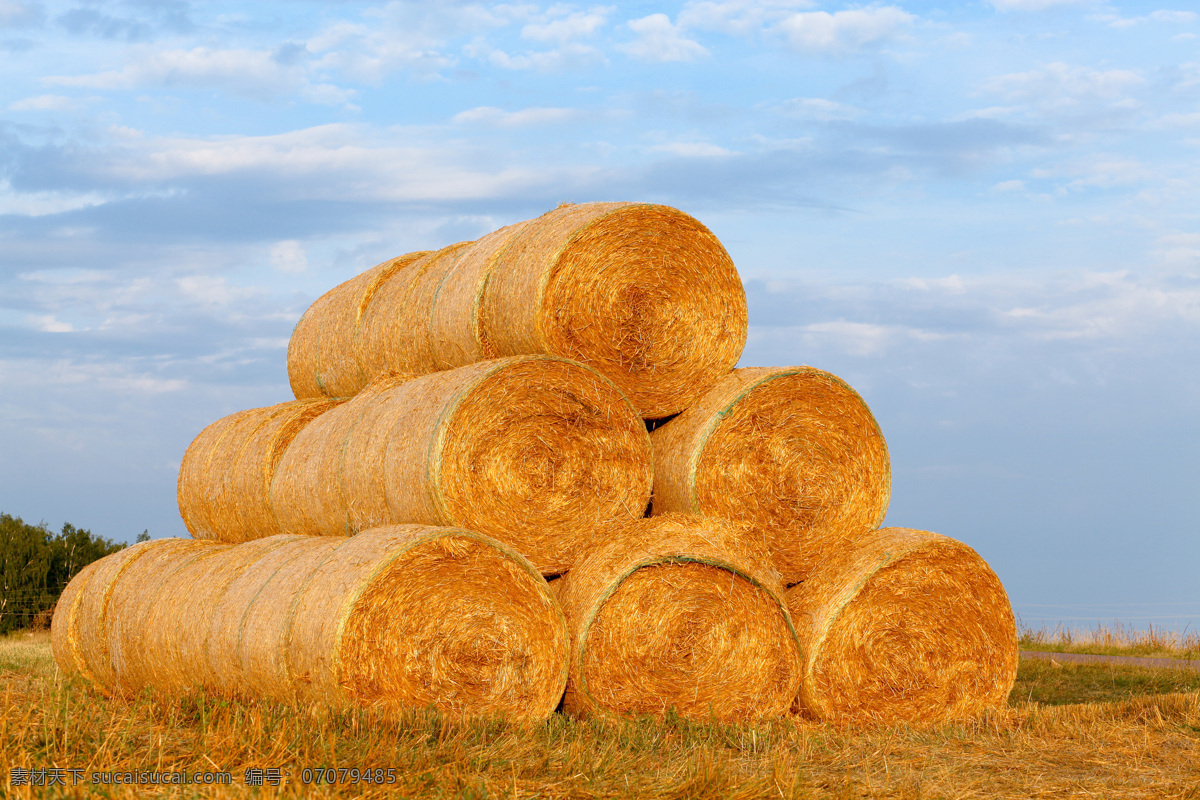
104, 539, 218, 694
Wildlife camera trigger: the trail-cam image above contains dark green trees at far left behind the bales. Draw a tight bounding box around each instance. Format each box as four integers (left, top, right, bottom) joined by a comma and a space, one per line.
0, 512, 139, 636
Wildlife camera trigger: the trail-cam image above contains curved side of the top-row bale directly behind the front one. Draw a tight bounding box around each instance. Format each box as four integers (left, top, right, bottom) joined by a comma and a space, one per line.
430, 221, 529, 369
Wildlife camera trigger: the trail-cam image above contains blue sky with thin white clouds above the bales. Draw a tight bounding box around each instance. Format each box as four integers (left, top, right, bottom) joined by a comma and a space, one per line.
0, 0, 1200, 630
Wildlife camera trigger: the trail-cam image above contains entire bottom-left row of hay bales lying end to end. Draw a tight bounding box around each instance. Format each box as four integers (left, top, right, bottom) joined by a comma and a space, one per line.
55, 525, 568, 720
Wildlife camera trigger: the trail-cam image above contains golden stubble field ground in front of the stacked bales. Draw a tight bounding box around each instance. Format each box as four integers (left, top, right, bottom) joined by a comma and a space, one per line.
0, 633, 1200, 800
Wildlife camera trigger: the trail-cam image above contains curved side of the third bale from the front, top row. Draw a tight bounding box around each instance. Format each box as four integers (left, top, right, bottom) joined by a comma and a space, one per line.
358, 241, 474, 378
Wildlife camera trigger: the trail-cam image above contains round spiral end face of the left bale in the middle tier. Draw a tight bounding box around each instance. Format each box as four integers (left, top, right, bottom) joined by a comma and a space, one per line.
434, 356, 653, 575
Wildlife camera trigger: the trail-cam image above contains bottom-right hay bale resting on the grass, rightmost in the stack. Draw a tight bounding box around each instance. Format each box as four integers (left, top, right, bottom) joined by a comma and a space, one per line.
787, 528, 1018, 724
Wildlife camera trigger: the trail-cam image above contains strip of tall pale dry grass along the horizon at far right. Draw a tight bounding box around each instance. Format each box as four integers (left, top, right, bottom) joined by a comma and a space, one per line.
1020, 621, 1200, 660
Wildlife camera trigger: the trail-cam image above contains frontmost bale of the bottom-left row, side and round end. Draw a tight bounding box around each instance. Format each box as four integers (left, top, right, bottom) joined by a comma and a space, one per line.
287, 525, 568, 720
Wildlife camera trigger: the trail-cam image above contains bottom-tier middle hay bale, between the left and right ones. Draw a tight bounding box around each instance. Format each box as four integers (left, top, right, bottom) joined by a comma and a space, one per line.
554, 515, 802, 721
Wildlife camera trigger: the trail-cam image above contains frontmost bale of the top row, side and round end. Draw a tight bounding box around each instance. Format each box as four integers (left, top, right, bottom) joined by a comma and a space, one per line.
481, 203, 748, 417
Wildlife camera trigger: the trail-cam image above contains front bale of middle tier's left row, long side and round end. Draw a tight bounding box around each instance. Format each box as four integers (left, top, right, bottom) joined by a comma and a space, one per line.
272, 356, 653, 575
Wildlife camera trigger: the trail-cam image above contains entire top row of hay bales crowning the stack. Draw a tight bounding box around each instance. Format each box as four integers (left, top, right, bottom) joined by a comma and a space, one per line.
288, 203, 746, 419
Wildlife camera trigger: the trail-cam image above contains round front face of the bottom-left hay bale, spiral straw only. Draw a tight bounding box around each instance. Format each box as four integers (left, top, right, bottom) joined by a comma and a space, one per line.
338, 529, 568, 720
